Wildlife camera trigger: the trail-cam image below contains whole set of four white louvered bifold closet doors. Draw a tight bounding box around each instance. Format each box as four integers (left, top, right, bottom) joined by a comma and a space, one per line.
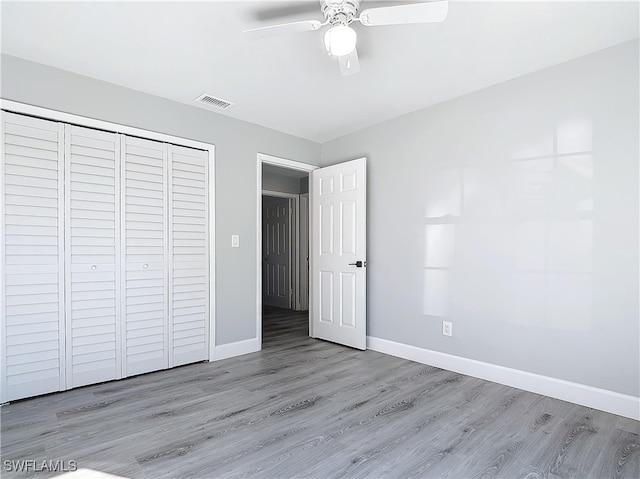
0, 112, 210, 402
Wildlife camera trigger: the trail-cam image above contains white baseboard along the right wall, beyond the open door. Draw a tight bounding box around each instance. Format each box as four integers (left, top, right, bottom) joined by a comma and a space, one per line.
367, 336, 640, 420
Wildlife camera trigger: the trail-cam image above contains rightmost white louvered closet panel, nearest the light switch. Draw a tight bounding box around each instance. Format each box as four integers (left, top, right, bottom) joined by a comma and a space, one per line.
169, 145, 209, 367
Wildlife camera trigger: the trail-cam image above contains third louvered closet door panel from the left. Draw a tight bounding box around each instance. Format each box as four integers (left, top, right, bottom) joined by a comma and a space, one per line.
121, 136, 169, 376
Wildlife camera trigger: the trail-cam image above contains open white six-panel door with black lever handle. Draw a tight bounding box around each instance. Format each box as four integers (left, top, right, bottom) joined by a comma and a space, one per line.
310, 158, 367, 349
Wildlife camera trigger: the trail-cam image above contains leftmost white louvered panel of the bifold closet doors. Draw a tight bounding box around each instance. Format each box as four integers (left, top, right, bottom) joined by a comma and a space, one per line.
0, 112, 65, 402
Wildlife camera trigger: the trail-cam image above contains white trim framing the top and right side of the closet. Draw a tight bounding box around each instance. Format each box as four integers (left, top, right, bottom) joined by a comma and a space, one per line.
0, 98, 216, 361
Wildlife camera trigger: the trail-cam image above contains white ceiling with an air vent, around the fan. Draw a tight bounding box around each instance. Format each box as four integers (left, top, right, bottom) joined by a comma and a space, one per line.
1, 0, 639, 142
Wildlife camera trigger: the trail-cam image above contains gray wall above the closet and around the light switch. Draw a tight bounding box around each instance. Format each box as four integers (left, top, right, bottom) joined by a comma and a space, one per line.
0, 55, 320, 344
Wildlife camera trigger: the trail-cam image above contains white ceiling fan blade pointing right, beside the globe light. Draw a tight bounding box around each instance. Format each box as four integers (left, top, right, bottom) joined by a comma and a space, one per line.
358, 0, 449, 27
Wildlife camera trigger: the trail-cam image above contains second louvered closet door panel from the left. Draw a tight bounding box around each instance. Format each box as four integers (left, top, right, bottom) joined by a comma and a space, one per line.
65, 125, 121, 388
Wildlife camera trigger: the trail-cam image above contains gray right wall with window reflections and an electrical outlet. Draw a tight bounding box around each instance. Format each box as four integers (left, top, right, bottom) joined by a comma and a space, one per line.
322, 41, 640, 396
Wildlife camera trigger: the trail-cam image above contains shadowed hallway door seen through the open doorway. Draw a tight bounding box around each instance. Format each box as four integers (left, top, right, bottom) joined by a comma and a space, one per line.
262, 196, 291, 308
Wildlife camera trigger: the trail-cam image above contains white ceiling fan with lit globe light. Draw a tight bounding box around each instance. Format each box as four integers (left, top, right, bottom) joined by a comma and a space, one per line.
244, 0, 449, 76
